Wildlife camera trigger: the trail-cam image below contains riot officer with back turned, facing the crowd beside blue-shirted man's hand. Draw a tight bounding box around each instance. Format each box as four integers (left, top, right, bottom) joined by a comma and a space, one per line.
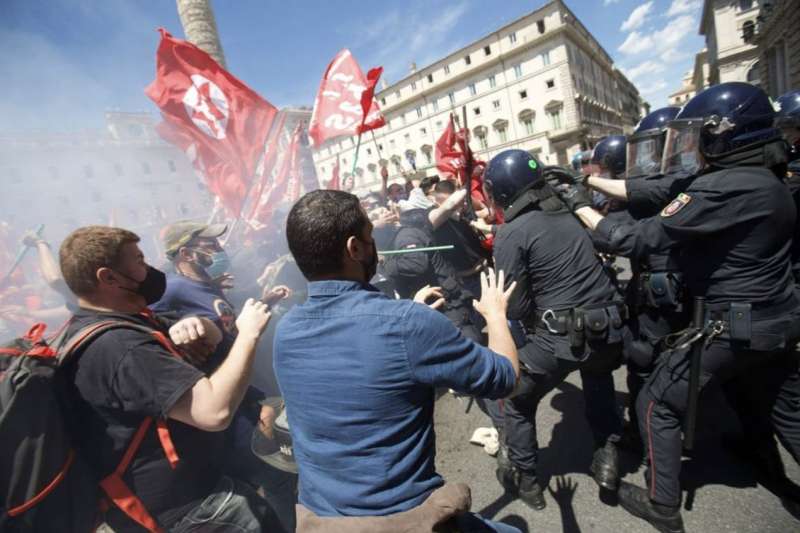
484, 150, 626, 509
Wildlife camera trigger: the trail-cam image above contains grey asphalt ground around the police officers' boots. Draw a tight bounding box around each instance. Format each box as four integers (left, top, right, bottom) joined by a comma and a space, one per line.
436, 370, 800, 533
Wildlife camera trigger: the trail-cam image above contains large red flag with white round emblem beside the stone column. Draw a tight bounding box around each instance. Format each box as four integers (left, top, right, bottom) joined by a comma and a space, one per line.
145, 28, 277, 216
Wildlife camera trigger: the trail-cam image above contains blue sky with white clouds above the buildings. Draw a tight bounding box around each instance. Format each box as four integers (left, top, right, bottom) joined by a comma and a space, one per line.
0, 0, 703, 134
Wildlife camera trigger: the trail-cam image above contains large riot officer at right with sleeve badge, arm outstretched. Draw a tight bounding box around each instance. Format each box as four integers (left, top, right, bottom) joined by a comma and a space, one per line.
564, 82, 800, 532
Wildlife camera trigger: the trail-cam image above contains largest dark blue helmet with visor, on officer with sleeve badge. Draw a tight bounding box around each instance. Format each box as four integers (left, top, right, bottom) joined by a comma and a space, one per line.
661, 82, 780, 174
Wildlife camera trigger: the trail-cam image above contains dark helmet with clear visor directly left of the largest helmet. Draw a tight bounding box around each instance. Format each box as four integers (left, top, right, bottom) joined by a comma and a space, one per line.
625, 107, 680, 178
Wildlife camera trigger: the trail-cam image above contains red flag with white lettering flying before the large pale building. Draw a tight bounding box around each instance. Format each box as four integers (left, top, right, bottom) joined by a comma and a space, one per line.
308, 48, 386, 146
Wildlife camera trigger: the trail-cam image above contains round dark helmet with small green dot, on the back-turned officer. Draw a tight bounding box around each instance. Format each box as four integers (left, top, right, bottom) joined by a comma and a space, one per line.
483, 150, 545, 209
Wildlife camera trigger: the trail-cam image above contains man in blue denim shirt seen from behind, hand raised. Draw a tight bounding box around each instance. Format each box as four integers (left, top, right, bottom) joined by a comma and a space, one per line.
274, 190, 519, 531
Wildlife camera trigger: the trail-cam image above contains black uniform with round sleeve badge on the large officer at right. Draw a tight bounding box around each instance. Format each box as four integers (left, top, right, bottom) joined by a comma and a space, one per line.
597, 167, 800, 506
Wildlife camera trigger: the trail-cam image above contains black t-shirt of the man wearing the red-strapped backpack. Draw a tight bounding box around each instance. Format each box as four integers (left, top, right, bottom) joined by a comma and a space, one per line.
68, 309, 224, 533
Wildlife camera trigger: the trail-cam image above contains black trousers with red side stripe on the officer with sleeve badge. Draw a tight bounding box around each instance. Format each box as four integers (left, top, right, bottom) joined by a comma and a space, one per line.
637, 330, 800, 506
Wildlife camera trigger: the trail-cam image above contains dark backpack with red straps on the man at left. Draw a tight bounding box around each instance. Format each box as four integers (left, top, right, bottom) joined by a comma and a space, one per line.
0, 321, 181, 533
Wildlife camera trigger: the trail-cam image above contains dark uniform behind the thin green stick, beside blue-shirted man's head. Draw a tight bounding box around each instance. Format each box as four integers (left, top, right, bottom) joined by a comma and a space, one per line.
383, 209, 482, 342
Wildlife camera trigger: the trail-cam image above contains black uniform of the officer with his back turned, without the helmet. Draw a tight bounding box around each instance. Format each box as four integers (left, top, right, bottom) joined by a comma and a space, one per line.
494, 193, 625, 475
